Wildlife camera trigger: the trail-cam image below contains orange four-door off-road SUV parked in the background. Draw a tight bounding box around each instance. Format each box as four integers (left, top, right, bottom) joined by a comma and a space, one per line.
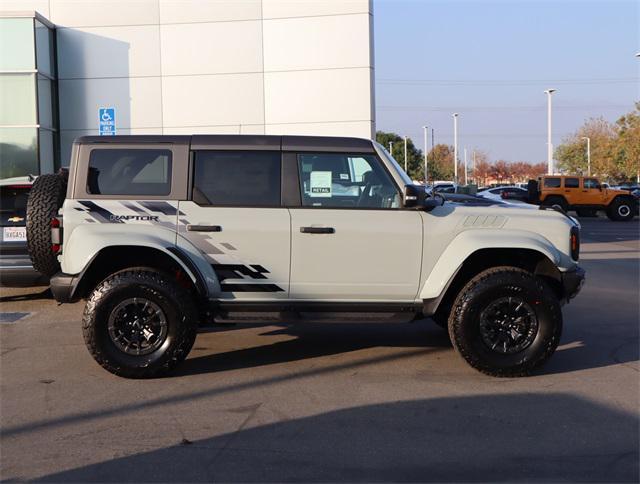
528, 175, 638, 221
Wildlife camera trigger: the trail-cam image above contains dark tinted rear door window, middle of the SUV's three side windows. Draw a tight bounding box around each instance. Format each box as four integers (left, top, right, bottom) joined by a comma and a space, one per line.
193, 151, 282, 207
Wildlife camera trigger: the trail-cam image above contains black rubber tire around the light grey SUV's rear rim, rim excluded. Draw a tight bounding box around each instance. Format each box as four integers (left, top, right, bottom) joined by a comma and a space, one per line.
82, 267, 198, 378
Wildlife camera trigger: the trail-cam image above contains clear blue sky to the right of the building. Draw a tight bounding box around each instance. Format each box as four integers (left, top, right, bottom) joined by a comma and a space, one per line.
374, 0, 640, 162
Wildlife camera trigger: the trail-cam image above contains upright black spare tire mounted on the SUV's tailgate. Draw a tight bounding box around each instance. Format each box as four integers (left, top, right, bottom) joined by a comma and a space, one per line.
27, 173, 67, 276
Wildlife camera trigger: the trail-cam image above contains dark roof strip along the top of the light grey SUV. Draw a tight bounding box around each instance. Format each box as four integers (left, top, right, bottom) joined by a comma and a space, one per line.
75, 134, 374, 153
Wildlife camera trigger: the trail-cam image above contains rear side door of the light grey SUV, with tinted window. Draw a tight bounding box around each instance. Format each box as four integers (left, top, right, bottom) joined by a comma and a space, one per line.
178, 148, 291, 300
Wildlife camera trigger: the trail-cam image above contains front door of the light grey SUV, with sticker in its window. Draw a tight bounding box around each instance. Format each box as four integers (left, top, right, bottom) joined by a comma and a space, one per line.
290, 153, 422, 302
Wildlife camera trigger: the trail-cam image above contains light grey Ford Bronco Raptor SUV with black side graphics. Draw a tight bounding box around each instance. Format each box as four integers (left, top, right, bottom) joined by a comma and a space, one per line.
27, 135, 584, 378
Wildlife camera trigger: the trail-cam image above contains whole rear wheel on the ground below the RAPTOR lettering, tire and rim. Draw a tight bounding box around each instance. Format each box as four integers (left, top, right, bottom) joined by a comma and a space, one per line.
82, 268, 198, 378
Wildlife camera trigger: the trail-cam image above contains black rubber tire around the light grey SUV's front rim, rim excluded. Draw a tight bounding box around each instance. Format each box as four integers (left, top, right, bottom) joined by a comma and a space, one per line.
449, 266, 562, 377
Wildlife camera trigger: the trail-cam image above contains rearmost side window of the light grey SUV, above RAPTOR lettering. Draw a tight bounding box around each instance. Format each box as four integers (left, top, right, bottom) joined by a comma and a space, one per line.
87, 149, 172, 196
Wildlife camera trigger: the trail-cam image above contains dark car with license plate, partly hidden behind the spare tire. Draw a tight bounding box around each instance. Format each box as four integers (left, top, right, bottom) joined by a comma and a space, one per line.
0, 176, 48, 286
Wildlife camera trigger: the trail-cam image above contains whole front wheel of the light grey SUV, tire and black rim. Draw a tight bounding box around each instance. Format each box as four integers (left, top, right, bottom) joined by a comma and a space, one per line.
449, 267, 562, 377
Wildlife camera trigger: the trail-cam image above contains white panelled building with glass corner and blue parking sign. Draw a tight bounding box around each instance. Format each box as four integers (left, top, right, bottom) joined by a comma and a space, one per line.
0, 0, 375, 178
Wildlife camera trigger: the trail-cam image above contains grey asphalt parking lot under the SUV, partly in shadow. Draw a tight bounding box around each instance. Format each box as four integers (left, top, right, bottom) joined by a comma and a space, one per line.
0, 218, 640, 482
